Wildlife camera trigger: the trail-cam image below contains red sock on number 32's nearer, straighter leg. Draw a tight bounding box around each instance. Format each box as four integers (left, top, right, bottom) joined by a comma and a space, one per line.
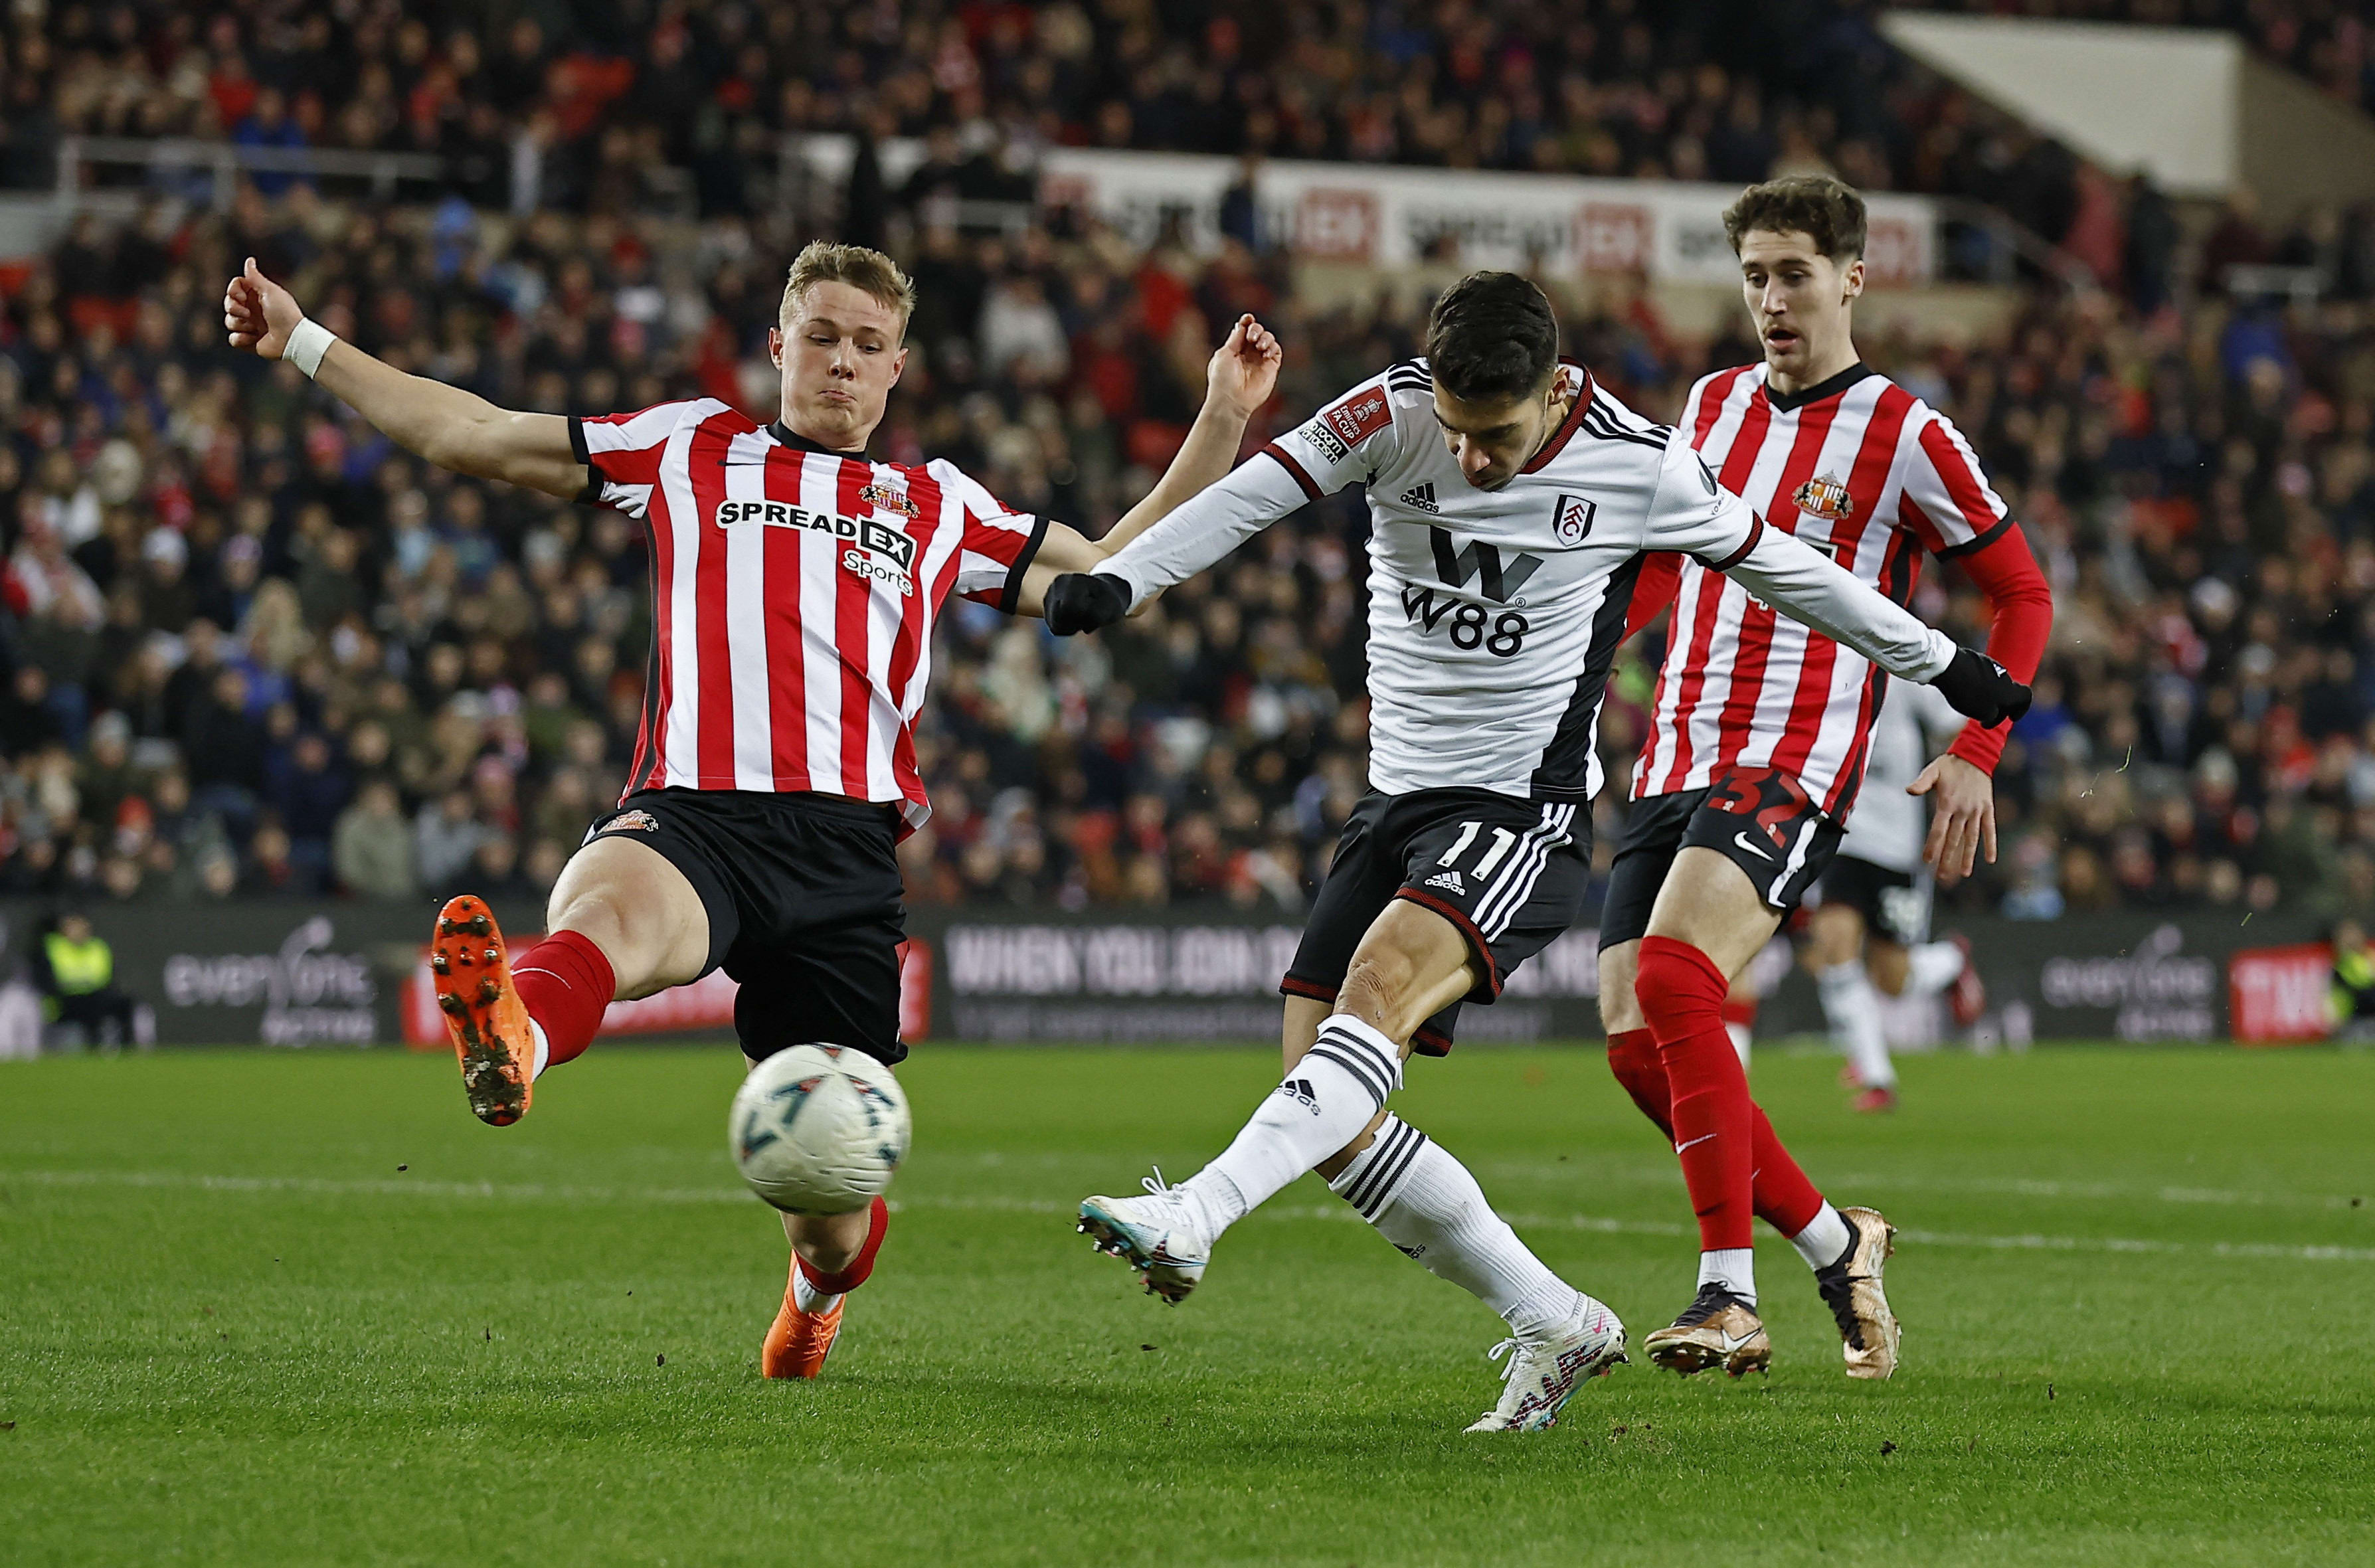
1634, 936, 1757, 1252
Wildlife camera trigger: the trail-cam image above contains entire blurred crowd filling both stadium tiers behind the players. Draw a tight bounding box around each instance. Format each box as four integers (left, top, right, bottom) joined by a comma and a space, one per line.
0, 0, 2375, 919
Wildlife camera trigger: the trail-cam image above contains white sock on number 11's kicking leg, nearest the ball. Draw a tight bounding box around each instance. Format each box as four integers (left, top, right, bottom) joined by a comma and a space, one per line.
1178, 1012, 1401, 1240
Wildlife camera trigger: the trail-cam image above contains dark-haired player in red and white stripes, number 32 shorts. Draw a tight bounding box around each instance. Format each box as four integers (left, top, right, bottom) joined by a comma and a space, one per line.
1601, 176, 2052, 1378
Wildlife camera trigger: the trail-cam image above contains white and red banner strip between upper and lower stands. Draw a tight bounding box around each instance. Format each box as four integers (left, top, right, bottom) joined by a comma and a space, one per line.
798, 135, 1938, 288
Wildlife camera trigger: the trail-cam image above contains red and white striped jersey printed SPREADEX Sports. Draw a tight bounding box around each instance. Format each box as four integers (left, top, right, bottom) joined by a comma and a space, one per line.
570, 399, 1047, 827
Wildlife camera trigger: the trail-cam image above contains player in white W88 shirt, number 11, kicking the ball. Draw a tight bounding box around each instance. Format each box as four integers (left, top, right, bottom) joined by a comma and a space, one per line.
1047, 273, 2026, 1431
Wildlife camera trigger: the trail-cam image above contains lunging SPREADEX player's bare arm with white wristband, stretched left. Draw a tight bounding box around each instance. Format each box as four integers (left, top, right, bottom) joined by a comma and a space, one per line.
223, 256, 589, 499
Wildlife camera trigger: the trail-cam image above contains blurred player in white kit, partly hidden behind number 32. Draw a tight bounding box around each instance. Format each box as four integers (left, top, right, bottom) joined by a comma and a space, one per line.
1805, 687, 1986, 1112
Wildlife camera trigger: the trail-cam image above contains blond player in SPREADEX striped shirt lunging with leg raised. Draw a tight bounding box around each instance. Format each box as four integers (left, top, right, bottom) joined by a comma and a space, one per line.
223, 242, 1280, 1378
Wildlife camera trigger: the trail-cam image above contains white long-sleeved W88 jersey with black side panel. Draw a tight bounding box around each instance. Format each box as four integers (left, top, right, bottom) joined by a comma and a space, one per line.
1097, 359, 1955, 801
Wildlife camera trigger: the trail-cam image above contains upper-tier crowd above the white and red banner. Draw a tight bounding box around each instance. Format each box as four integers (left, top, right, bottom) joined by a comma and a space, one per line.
0, 0, 2223, 240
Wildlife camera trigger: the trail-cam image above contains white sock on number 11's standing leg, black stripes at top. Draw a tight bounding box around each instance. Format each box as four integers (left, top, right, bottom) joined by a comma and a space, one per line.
1328, 1116, 1584, 1340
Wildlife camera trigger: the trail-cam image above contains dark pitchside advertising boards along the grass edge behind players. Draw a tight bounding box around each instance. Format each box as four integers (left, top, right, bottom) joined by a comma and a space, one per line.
0, 901, 2330, 1050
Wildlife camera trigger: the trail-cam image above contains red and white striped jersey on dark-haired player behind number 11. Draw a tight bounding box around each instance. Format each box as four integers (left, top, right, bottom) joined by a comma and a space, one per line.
1632, 361, 2012, 818
